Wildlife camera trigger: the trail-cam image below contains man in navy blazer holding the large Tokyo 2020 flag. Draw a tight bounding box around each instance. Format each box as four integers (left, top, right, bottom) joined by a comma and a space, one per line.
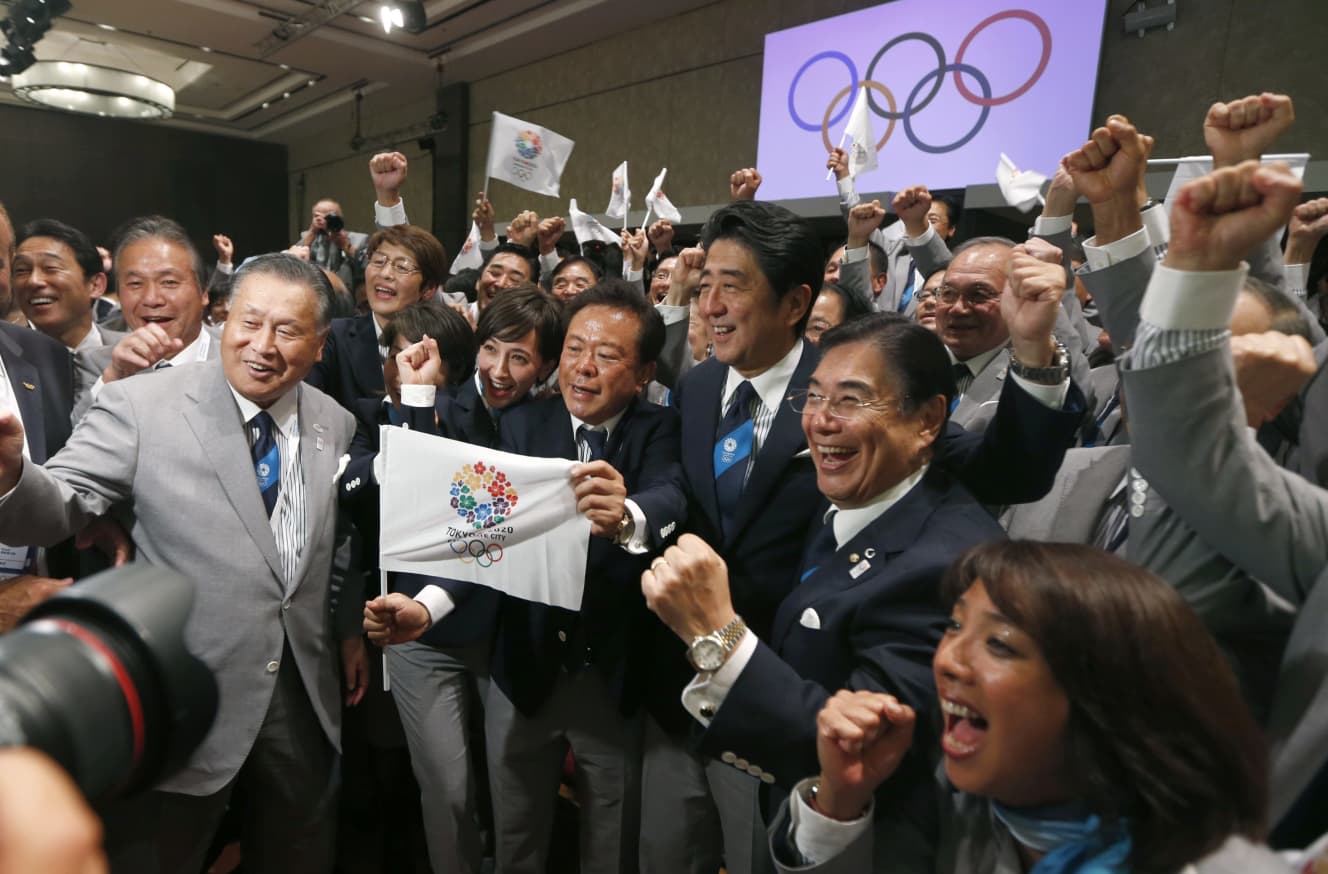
367, 280, 687, 874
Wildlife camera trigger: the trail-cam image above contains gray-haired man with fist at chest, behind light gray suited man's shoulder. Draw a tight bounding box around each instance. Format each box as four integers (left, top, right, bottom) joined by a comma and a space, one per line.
74, 215, 222, 421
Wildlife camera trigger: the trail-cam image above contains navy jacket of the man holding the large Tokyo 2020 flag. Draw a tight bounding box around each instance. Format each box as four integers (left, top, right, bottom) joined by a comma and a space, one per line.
491, 396, 687, 716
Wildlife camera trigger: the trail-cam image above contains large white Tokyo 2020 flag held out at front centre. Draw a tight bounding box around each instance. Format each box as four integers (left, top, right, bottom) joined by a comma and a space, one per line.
378, 426, 590, 610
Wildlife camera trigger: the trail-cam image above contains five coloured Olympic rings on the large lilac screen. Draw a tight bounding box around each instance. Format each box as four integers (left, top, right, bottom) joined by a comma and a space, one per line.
789, 9, 1052, 154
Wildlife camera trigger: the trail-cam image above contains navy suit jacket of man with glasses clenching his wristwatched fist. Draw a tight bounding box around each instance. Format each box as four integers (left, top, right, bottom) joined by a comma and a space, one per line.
701, 468, 1005, 788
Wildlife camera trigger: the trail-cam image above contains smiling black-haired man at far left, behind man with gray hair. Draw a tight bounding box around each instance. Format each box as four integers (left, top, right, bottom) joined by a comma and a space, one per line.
13, 219, 125, 422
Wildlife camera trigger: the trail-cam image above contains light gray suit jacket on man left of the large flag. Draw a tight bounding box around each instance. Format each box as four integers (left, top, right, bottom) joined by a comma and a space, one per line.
0, 363, 359, 794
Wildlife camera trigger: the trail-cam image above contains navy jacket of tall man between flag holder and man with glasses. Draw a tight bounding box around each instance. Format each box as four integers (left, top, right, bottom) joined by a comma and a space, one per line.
651, 344, 1085, 732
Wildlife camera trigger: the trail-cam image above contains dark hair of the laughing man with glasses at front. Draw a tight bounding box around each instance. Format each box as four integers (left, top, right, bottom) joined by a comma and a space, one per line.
821, 312, 956, 425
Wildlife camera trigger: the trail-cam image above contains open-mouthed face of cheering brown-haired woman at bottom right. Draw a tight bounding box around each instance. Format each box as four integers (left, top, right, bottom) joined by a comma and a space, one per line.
932, 580, 1073, 806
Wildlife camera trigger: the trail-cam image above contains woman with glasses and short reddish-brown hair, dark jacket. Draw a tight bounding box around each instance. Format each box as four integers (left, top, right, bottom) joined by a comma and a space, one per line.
305, 224, 448, 412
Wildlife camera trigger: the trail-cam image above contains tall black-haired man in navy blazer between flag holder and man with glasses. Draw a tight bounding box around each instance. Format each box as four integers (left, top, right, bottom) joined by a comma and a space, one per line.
640, 202, 1084, 873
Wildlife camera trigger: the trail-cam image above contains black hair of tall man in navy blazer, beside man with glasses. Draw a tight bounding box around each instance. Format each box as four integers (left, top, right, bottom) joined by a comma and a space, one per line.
701, 201, 825, 337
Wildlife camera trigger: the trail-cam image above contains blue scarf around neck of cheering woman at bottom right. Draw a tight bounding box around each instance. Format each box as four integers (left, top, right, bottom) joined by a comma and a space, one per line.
991, 801, 1130, 874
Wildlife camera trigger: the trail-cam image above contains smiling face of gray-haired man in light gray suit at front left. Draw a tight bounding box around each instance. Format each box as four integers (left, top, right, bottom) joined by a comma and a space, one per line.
222, 274, 327, 406
